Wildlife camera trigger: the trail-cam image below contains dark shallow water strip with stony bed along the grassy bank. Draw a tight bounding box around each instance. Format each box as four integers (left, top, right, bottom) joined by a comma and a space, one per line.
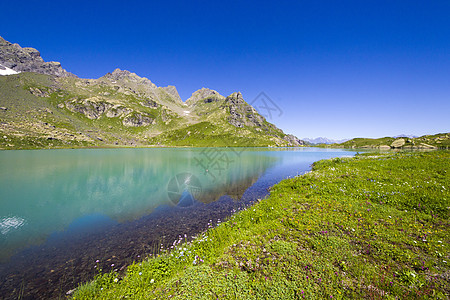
0, 149, 354, 299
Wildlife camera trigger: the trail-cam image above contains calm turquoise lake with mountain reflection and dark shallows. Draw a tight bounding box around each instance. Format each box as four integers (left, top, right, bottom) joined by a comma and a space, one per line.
0, 148, 354, 299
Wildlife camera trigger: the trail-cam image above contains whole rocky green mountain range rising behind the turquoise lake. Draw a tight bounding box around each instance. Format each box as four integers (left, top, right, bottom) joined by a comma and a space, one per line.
0, 38, 304, 149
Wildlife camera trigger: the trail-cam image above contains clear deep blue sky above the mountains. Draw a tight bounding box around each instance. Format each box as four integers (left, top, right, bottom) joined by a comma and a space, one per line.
0, 0, 450, 138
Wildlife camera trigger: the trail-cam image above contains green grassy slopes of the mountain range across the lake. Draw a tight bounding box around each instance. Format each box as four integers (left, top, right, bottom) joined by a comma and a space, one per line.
0, 72, 298, 150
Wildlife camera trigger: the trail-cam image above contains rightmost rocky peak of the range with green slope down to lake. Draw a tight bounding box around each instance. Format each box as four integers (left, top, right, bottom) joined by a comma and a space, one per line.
149, 90, 303, 146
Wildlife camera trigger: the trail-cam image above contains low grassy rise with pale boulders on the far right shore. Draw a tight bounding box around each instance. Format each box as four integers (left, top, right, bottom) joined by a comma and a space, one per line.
328, 133, 450, 150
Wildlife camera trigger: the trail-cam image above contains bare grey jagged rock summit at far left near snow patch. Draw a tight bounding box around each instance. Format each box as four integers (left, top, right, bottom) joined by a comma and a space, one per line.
0, 37, 77, 77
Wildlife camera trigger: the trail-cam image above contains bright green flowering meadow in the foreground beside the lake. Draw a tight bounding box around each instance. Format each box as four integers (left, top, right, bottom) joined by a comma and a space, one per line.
73, 151, 450, 299
